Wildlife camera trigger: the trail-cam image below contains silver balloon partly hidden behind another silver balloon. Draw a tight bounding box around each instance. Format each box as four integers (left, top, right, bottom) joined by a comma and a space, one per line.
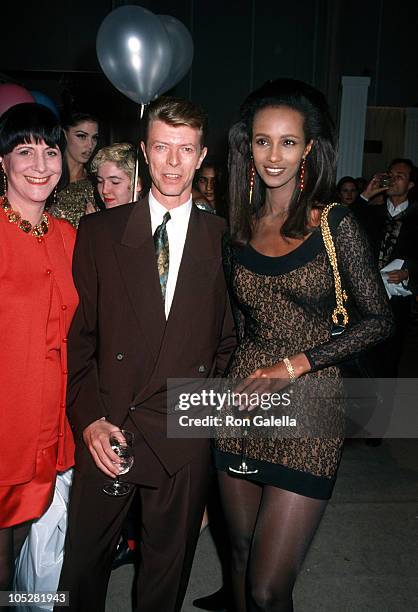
157, 15, 193, 94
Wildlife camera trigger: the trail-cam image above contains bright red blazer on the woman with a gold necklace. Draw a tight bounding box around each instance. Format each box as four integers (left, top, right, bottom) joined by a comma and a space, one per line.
0, 211, 78, 485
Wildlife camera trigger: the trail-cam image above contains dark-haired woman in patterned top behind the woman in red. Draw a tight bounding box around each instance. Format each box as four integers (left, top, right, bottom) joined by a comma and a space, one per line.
50, 112, 99, 228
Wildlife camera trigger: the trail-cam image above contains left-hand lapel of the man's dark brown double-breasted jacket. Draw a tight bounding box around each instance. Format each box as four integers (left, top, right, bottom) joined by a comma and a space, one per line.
114, 198, 166, 361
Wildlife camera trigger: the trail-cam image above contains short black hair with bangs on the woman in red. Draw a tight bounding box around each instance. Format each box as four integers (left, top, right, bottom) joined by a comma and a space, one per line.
0, 102, 65, 157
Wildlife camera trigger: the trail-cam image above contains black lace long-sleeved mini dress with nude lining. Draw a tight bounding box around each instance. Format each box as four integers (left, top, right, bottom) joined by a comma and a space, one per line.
215, 206, 392, 499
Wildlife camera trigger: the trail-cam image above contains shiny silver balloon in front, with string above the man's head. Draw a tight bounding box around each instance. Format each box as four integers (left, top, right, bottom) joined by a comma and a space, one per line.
96, 6, 172, 104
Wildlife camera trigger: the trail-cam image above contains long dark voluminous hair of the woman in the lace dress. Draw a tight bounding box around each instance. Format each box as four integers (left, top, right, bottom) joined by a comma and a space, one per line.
229, 78, 336, 244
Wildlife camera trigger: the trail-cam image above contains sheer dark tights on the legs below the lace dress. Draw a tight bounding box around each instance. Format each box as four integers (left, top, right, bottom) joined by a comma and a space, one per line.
219, 472, 327, 612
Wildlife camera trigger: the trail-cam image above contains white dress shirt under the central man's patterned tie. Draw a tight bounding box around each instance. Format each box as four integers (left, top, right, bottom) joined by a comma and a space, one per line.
148, 191, 192, 319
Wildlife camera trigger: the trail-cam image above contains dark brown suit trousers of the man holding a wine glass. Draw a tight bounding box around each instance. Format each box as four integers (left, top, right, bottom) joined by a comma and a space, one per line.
59, 445, 211, 612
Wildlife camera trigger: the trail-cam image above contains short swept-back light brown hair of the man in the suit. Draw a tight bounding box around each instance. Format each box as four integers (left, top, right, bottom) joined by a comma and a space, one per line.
144, 96, 207, 146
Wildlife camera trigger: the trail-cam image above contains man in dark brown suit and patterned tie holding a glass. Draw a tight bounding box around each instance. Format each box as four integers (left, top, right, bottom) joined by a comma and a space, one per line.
59, 98, 235, 612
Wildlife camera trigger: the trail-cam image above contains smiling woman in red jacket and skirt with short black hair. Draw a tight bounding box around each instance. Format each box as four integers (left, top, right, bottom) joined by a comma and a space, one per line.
0, 104, 77, 590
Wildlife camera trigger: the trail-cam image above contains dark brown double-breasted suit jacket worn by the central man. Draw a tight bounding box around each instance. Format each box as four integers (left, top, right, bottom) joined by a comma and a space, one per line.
68, 198, 236, 485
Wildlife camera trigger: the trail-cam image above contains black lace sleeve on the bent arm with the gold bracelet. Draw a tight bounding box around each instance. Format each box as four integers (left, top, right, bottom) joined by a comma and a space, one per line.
306, 209, 393, 371
